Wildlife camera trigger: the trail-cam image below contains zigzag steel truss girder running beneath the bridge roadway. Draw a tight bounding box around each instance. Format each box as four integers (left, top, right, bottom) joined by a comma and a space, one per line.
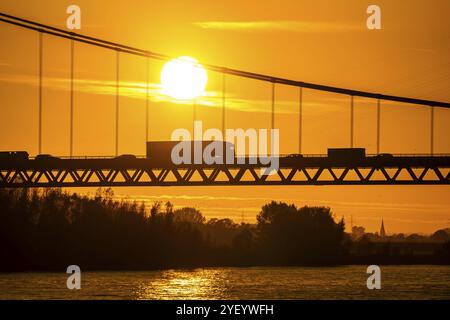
0, 165, 450, 188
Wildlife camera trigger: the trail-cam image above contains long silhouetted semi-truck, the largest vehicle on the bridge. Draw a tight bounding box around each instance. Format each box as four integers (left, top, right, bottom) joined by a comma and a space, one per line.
147, 140, 235, 165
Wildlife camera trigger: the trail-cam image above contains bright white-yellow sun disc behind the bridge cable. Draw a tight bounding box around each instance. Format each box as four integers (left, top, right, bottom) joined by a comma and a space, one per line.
161, 56, 208, 100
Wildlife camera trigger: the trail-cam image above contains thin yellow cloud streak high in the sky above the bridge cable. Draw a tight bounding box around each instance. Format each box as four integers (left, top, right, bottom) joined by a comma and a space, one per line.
194, 20, 360, 33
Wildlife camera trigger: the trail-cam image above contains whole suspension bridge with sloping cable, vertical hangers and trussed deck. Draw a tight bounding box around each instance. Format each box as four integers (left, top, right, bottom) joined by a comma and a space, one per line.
0, 13, 450, 188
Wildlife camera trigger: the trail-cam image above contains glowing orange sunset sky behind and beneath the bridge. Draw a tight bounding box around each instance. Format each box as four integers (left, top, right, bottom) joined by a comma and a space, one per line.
0, 0, 450, 233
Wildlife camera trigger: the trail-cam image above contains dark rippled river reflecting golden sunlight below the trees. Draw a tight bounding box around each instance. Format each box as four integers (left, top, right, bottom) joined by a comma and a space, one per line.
0, 266, 450, 300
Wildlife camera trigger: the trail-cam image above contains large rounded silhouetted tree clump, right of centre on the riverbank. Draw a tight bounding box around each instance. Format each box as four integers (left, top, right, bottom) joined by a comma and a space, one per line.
257, 201, 346, 265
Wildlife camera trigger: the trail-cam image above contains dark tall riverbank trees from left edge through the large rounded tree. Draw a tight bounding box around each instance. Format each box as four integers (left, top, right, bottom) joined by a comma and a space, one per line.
0, 188, 446, 271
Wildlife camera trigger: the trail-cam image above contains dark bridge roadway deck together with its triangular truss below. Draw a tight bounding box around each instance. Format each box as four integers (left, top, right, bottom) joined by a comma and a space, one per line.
0, 156, 450, 188
